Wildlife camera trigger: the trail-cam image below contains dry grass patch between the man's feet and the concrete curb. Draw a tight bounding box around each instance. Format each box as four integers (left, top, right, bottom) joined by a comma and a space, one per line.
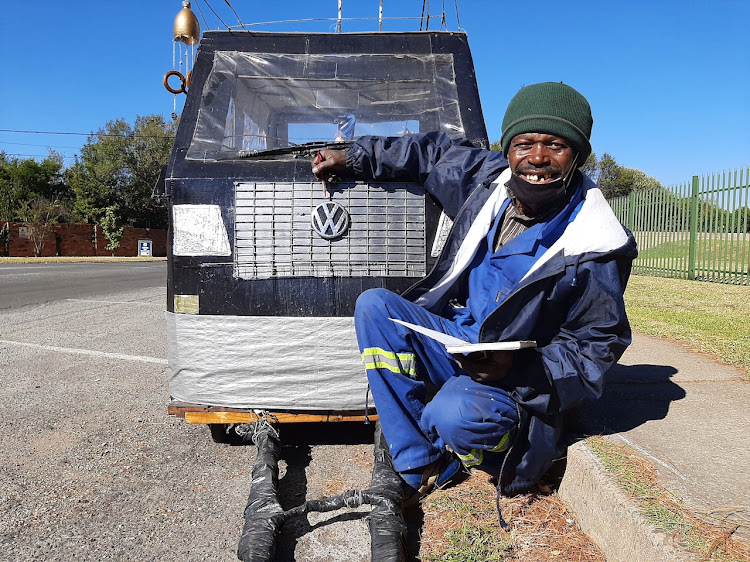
420, 471, 604, 562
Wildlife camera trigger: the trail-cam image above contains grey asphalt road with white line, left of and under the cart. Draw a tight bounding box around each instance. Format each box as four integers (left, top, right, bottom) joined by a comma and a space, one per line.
0, 262, 372, 562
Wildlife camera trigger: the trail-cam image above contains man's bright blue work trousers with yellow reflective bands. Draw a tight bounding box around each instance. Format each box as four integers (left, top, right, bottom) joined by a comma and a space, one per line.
354, 289, 518, 472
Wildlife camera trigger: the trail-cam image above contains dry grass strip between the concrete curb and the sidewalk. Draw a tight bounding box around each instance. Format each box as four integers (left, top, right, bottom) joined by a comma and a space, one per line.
586, 436, 750, 562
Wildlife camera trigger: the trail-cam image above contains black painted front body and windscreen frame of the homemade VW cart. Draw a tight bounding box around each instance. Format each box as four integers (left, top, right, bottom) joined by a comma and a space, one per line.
162, 32, 488, 316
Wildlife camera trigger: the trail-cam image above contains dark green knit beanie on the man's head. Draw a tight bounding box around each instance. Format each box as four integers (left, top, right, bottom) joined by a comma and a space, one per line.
500, 82, 594, 166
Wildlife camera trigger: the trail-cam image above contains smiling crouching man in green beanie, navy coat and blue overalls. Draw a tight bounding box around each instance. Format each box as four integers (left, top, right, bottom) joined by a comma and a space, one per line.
313, 82, 636, 497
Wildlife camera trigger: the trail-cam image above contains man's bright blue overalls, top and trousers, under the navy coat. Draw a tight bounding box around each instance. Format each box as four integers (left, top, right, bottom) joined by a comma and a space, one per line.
354, 203, 556, 472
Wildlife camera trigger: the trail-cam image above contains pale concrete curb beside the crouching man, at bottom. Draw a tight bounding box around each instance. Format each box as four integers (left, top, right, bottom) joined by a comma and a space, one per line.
558, 441, 698, 562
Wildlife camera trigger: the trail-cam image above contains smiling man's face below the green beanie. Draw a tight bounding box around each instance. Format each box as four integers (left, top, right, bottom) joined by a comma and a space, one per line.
507, 133, 576, 184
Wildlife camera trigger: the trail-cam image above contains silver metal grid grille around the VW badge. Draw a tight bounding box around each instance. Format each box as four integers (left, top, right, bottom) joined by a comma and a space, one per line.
234, 183, 427, 279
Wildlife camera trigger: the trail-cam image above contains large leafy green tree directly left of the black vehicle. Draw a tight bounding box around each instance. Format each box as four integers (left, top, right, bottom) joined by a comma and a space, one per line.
67, 115, 176, 228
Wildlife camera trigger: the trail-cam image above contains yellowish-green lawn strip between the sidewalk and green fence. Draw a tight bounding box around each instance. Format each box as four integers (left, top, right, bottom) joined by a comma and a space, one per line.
625, 275, 750, 380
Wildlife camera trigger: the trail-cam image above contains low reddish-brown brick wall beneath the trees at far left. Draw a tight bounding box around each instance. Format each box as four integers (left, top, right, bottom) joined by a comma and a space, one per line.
0, 222, 167, 257
